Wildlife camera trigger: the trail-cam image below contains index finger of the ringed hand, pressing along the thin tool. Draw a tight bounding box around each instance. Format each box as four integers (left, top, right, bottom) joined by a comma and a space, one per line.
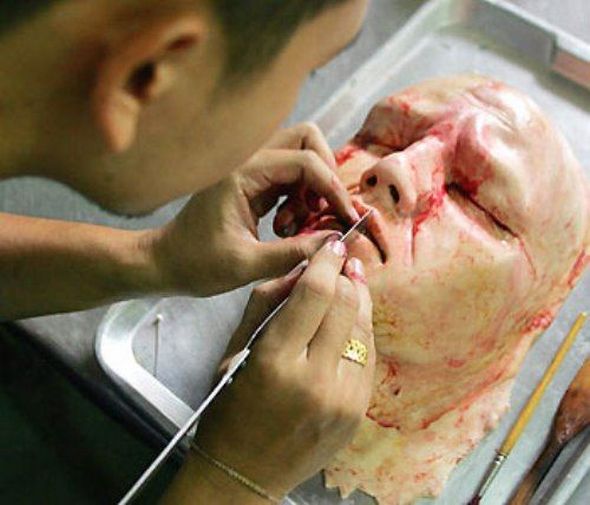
264, 241, 346, 355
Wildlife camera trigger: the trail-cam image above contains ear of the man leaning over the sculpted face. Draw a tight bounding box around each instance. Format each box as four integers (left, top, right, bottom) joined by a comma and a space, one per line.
91, 14, 206, 152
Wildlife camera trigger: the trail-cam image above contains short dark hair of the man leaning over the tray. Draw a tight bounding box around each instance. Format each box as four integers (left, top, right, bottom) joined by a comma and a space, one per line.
0, 0, 347, 78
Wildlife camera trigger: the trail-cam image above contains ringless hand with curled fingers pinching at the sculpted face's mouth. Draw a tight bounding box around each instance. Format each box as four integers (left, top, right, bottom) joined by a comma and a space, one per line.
148, 124, 359, 296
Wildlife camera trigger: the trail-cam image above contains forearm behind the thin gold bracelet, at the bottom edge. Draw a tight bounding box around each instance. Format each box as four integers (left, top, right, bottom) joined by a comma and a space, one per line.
161, 452, 271, 505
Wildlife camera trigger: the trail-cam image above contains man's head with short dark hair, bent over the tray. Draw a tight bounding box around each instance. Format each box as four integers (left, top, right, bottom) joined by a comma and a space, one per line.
0, 0, 367, 213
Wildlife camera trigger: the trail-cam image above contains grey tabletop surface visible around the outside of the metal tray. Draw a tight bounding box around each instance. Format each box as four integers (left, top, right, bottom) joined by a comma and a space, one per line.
0, 0, 590, 438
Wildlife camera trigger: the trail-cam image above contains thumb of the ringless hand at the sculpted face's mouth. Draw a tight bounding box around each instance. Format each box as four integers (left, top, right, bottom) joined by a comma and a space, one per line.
253, 230, 342, 278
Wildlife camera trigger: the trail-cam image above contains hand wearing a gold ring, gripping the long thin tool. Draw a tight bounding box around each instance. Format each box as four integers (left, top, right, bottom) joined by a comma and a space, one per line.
191, 242, 375, 496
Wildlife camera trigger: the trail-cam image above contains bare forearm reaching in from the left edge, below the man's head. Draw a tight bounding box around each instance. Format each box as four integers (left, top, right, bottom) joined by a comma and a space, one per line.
0, 213, 159, 321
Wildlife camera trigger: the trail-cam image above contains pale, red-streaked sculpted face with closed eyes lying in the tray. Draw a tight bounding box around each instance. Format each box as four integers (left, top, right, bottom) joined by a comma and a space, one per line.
308, 76, 590, 504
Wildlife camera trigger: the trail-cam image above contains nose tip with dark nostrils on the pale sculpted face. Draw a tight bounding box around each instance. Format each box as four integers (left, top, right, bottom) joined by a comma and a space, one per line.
361, 153, 418, 216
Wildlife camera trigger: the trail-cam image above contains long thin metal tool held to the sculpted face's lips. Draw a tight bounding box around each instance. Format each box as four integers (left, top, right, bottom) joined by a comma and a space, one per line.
118, 210, 373, 505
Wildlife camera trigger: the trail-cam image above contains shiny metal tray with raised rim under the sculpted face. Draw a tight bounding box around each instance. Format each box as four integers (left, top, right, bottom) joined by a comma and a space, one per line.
96, 0, 590, 505
